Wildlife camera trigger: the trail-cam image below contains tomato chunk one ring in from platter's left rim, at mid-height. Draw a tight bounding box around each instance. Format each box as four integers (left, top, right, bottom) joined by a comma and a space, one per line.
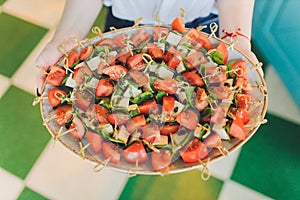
74, 90, 94, 111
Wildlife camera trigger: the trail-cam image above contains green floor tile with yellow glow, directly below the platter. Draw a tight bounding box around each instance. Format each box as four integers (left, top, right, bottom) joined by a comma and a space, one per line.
120, 170, 223, 200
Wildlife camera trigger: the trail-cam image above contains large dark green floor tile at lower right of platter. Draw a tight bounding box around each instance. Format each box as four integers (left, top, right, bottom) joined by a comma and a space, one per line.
232, 114, 300, 200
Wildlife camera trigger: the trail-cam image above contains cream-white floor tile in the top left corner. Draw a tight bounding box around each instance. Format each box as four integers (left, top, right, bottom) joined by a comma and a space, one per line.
3, 0, 65, 28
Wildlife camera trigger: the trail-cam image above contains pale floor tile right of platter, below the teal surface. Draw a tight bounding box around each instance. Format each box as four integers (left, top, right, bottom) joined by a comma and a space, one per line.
265, 66, 300, 124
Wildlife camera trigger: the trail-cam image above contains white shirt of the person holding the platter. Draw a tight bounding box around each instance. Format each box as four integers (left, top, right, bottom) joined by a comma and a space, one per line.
104, 0, 217, 24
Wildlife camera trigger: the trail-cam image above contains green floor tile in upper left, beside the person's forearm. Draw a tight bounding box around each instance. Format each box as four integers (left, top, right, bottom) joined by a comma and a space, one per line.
0, 12, 47, 77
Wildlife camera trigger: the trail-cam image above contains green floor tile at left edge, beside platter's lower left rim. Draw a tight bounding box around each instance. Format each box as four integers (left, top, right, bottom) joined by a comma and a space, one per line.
0, 86, 50, 179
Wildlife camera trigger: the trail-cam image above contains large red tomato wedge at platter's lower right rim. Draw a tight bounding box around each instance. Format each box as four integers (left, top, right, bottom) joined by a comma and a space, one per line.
180, 138, 209, 163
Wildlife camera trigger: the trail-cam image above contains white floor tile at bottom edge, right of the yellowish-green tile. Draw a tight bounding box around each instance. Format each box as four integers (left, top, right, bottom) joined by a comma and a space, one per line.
218, 181, 271, 200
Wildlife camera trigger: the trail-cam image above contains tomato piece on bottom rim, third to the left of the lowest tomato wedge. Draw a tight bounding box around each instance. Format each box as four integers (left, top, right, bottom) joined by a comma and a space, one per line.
102, 142, 121, 164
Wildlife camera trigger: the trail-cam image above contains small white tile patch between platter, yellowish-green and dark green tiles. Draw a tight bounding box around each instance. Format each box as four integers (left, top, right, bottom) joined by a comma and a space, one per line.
208, 148, 240, 180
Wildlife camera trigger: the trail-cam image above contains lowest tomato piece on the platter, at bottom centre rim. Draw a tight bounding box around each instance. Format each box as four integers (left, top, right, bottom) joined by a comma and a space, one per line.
151, 149, 171, 171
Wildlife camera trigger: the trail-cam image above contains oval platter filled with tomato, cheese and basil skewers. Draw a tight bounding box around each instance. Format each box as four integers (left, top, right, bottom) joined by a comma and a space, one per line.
34, 17, 267, 177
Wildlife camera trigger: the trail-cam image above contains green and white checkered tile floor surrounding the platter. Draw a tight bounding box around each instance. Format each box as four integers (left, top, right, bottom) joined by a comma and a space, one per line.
0, 0, 300, 200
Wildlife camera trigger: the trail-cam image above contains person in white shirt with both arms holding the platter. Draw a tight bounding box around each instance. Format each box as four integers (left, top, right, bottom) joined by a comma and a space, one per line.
35, 0, 258, 94
